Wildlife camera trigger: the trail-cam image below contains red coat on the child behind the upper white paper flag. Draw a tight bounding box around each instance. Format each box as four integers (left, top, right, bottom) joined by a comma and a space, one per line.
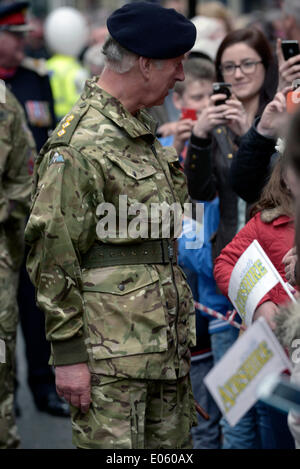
214, 209, 295, 306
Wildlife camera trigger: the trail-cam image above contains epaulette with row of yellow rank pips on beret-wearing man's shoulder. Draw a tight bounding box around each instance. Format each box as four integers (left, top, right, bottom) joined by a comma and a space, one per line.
48, 102, 89, 147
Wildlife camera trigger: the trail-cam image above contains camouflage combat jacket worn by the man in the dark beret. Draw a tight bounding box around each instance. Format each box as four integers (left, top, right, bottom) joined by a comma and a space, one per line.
26, 79, 194, 379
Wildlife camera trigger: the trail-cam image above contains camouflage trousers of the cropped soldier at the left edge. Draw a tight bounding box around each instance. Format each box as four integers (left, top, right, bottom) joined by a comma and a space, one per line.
0, 266, 20, 449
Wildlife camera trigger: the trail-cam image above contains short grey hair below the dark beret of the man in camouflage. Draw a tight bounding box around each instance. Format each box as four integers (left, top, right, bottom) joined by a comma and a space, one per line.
102, 36, 138, 74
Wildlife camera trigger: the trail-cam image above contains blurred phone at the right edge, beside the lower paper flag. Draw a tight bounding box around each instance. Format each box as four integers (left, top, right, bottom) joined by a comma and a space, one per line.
257, 375, 300, 414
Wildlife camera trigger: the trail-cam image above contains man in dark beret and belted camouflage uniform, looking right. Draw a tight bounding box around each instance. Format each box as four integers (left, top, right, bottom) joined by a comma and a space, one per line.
26, 2, 197, 449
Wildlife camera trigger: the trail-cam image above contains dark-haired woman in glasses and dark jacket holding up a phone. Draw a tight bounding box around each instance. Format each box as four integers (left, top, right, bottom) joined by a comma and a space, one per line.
185, 29, 277, 257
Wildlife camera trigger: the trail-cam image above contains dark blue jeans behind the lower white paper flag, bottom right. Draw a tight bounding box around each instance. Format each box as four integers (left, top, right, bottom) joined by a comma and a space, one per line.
211, 327, 294, 449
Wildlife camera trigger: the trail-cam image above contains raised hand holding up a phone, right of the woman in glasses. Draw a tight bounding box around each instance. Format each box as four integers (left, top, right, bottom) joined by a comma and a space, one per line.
257, 87, 291, 138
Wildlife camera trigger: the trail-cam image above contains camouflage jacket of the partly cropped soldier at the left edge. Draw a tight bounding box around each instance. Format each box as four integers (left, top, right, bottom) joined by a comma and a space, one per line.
0, 89, 36, 271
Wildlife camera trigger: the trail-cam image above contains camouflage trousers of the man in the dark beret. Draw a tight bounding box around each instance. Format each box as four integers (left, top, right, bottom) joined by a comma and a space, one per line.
71, 375, 197, 449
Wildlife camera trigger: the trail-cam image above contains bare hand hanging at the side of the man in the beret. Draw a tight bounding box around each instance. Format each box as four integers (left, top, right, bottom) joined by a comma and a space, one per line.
55, 363, 91, 413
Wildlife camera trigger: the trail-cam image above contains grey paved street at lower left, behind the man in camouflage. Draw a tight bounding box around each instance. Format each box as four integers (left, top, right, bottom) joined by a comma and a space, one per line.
17, 329, 74, 449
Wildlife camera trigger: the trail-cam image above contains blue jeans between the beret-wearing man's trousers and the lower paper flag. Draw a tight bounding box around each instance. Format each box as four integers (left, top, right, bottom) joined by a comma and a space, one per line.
190, 356, 222, 449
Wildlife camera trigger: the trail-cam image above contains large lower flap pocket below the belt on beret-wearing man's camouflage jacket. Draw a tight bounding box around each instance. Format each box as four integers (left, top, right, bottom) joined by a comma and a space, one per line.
82, 265, 167, 360
